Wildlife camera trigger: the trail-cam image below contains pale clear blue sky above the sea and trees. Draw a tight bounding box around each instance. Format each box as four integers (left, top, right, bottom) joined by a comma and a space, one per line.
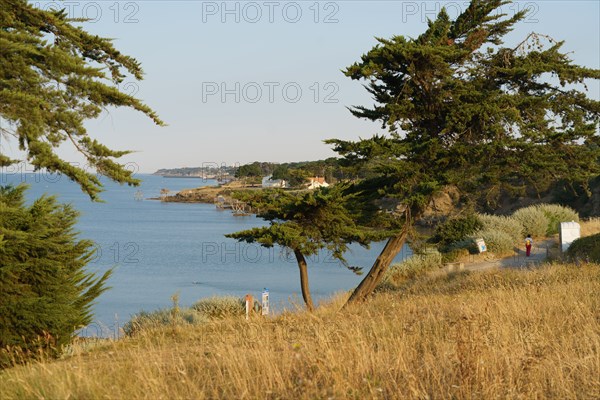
4, 0, 600, 173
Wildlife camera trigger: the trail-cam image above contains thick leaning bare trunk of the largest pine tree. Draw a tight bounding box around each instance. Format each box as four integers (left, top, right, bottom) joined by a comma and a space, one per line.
344, 225, 409, 307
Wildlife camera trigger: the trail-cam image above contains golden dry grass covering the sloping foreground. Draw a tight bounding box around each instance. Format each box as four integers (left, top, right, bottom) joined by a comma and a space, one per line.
0, 264, 600, 399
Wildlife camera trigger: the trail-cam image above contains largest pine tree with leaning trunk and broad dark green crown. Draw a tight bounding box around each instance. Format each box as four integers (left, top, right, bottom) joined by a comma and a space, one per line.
327, 0, 600, 303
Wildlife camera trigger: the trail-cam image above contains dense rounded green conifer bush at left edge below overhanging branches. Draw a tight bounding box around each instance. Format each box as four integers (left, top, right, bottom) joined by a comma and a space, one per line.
0, 185, 110, 366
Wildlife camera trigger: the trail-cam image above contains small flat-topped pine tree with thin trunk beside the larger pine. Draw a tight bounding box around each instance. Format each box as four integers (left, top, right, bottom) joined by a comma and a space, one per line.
225, 184, 385, 311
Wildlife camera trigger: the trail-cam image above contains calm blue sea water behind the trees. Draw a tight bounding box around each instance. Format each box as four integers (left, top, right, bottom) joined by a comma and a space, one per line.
0, 173, 408, 336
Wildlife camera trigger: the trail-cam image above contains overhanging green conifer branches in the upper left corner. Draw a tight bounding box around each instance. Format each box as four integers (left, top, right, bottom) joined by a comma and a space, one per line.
0, 0, 163, 199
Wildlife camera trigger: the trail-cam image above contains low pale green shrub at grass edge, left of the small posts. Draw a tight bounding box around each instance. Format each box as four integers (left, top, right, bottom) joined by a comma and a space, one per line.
123, 308, 208, 336
